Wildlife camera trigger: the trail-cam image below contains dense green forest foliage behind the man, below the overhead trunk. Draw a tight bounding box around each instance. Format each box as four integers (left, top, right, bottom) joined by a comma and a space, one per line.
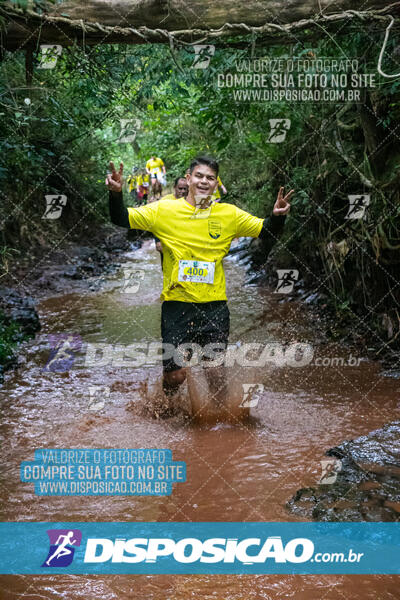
0, 30, 400, 350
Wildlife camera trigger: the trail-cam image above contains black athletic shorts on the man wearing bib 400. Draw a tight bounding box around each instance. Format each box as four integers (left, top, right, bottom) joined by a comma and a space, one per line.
161, 300, 229, 371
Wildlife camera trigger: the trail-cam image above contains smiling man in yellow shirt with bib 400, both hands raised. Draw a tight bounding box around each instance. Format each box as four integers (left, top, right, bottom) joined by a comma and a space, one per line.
106, 157, 294, 395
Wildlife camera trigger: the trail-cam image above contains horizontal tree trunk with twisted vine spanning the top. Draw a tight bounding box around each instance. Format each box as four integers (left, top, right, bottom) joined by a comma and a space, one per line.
0, 0, 400, 49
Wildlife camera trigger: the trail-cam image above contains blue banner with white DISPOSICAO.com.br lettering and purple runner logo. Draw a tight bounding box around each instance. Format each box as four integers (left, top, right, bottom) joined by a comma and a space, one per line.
0, 522, 400, 575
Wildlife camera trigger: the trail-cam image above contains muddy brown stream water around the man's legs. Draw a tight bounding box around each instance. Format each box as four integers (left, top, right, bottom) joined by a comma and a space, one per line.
0, 242, 400, 600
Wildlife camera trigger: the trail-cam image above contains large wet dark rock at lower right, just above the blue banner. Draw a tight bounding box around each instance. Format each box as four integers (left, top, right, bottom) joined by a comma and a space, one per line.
287, 421, 400, 521
